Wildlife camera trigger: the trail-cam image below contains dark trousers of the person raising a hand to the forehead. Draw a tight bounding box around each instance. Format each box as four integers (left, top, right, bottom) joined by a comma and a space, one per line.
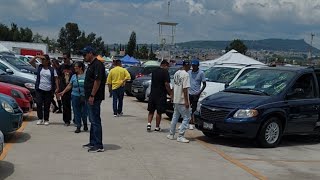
36, 89, 53, 121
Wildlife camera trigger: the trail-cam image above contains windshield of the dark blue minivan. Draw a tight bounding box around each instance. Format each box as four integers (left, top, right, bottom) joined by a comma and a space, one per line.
225, 69, 295, 96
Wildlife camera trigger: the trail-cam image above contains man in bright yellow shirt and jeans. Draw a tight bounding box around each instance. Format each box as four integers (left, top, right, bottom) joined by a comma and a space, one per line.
107, 59, 131, 117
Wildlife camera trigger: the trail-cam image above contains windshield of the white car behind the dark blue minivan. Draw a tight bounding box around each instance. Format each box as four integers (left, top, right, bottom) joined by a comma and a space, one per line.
205, 67, 241, 83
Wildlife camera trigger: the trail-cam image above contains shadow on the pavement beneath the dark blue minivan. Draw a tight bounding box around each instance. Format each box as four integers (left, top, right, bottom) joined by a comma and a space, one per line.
191, 135, 320, 148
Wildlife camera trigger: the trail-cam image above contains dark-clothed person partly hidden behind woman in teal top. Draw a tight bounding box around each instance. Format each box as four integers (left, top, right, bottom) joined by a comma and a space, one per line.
58, 53, 74, 126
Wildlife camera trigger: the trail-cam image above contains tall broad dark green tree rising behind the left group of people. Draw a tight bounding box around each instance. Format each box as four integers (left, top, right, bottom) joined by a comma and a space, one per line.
58, 22, 81, 53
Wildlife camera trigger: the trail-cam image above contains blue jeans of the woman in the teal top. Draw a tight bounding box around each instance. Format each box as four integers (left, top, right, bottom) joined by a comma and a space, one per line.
71, 95, 88, 129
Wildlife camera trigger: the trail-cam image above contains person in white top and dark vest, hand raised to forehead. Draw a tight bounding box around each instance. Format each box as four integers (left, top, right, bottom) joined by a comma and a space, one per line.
29, 54, 59, 126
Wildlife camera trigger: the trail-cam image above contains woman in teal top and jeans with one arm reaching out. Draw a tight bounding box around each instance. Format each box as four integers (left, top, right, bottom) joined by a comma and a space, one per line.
59, 62, 88, 133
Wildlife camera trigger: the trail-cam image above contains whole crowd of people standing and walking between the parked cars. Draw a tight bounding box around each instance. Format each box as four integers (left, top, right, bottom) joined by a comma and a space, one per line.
30, 46, 206, 152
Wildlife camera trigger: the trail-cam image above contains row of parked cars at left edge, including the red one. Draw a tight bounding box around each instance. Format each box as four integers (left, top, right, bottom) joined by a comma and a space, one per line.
0, 52, 36, 140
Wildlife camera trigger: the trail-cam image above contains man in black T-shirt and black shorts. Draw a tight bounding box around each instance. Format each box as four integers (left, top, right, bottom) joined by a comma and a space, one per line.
147, 60, 172, 131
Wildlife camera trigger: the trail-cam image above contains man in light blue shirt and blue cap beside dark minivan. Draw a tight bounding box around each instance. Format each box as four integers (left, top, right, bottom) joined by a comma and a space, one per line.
189, 60, 207, 130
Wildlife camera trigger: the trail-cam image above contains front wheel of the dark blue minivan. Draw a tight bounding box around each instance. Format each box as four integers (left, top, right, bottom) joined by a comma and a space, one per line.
257, 117, 282, 148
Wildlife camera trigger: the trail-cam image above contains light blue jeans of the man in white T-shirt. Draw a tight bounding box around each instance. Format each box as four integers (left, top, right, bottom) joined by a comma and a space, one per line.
170, 104, 191, 137
